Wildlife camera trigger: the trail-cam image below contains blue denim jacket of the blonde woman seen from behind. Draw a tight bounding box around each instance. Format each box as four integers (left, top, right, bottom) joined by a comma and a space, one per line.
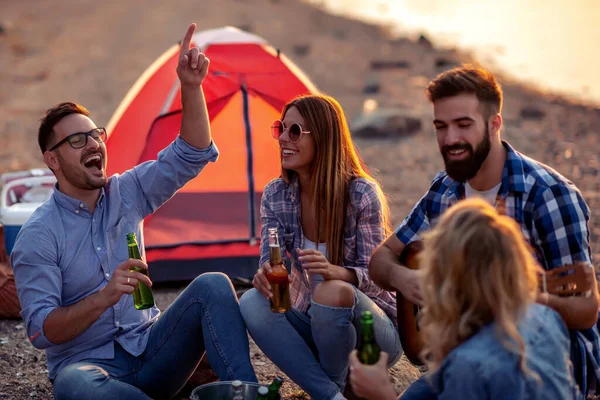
432, 304, 583, 400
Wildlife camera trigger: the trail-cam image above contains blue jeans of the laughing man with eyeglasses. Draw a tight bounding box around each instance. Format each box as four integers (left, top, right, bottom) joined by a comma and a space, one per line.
54, 273, 257, 400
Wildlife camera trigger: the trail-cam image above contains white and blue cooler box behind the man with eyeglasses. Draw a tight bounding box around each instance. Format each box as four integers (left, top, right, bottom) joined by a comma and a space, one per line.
0, 176, 56, 255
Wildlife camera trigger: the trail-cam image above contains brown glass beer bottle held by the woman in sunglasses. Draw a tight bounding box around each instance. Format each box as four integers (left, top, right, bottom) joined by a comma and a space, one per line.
267, 228, 292, 313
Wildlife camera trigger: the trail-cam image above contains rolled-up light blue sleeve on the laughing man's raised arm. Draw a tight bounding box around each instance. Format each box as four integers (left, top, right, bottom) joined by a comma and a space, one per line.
119, 136, 219, 218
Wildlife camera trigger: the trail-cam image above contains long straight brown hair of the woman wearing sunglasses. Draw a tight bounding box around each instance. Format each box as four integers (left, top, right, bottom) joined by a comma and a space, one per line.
281, 95, 391, 265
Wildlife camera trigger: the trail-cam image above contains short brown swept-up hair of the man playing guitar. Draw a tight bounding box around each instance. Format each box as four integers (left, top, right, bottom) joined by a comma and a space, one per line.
425, 64, 503, 119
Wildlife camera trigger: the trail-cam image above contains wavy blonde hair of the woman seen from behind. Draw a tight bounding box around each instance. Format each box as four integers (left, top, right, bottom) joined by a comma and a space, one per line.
420, 199, 540, 375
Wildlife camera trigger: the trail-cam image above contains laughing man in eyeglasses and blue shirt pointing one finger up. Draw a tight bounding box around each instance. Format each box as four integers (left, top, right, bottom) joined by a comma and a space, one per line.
11, 24, 257, 399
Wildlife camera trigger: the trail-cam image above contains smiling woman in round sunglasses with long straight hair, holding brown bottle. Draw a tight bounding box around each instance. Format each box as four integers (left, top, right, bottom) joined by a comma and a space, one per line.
240, 95, 402, 400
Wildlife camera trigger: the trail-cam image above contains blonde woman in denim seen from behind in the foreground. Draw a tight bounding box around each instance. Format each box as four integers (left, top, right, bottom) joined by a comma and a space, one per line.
350, 198, 593, 400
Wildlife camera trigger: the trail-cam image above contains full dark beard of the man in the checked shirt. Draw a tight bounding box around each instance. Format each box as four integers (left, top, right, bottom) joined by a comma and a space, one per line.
442, 124, 492, 183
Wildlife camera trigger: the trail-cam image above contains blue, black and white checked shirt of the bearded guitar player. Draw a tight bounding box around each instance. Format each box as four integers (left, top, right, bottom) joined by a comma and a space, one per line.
395, 142, 600, 393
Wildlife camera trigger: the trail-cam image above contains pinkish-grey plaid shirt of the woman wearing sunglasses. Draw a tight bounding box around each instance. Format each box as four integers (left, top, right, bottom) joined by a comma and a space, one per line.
259, 178, 397, 325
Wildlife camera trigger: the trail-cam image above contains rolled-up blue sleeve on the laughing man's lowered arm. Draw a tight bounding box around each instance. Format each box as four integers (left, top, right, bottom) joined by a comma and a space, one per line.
11, 224, 62, 349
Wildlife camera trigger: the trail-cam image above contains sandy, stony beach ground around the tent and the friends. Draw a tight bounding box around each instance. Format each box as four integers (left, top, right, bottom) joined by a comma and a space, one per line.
0, 0, 600, 399
